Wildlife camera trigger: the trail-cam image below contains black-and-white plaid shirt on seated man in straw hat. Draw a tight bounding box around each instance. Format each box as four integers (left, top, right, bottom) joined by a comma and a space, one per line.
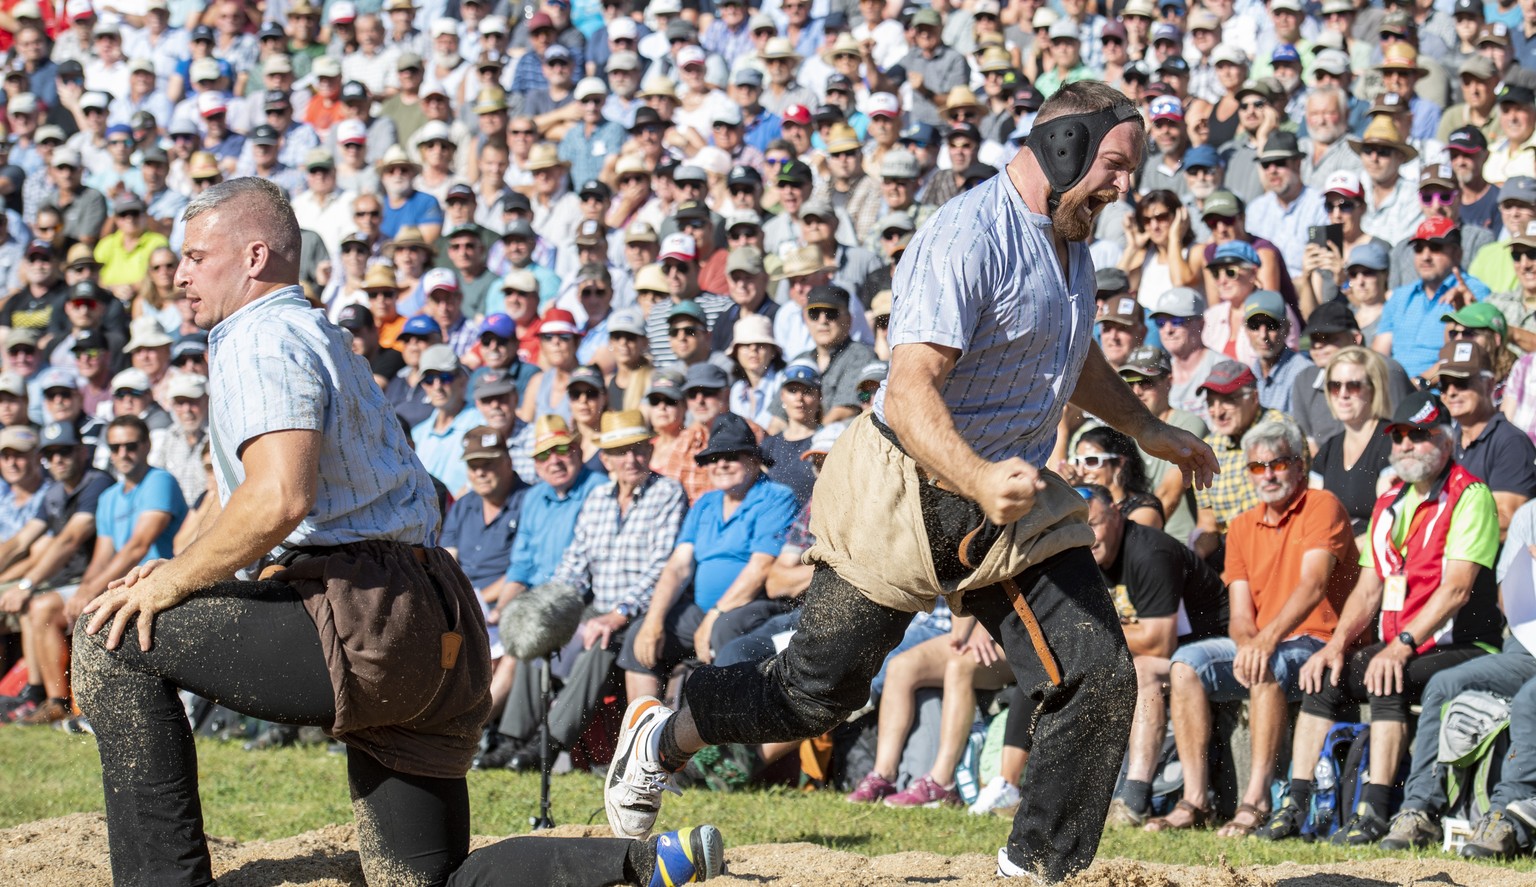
553, 473, 688, 618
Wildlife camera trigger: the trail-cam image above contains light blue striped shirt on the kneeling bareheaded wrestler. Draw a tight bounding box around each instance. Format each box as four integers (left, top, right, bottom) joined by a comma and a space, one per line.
209, 286, 439, 559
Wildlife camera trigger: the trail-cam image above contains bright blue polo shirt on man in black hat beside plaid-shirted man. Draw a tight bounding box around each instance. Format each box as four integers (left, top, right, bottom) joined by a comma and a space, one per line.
677, 475, 800, 610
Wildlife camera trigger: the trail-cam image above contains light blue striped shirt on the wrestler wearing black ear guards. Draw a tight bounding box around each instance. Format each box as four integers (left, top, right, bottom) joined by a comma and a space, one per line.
874, 172, 1095, 466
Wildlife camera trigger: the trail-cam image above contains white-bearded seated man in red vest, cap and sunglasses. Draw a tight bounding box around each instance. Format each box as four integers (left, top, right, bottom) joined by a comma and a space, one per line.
1261, 392, 1499, 845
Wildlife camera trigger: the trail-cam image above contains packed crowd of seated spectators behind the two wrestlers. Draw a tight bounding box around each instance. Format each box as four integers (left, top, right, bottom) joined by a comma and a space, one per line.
0, 0, 1536, 856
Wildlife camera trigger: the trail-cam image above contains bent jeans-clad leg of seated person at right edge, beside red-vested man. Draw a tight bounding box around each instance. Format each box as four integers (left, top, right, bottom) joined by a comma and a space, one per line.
1401, 636, 1536, 819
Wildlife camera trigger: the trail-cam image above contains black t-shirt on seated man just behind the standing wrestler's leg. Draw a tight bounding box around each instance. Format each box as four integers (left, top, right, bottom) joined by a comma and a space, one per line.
1101, 521, 1229, 643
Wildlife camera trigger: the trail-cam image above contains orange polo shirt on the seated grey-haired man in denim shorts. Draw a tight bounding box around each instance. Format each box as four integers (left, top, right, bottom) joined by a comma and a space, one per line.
1221, 488, 1359, 643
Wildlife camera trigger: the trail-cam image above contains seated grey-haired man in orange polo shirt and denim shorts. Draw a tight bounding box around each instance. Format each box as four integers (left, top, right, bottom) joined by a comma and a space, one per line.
1146, 420, 1359, 836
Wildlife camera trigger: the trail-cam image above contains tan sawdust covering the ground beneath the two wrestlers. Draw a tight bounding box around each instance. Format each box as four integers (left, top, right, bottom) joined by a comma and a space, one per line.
0, 813, 1536, 887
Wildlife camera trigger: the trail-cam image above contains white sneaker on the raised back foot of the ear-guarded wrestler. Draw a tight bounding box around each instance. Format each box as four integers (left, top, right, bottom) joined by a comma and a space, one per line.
602, 696, 682, 841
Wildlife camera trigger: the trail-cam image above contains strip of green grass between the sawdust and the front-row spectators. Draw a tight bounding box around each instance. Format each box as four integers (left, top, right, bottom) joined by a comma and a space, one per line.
0, 727, 1536, 872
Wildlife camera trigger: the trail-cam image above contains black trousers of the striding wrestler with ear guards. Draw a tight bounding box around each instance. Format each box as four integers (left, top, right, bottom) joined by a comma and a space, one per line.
684, 490, 1137, 881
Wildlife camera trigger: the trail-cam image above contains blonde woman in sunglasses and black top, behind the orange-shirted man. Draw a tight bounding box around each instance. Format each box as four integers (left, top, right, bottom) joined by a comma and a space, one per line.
1312, 346, 1393, 537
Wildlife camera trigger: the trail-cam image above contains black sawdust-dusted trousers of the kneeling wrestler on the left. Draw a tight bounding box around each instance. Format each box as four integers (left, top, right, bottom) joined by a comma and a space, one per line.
74, 581, 633, 887
